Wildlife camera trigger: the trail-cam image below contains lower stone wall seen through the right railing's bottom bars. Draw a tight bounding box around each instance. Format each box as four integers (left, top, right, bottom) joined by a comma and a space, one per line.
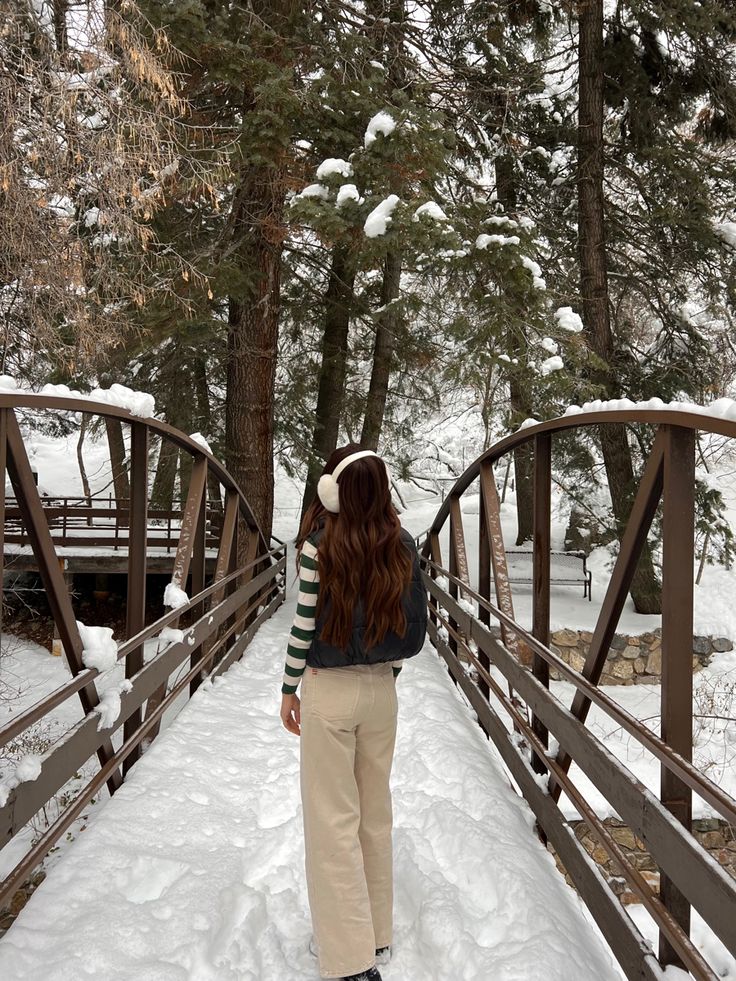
548, 818, 736, 905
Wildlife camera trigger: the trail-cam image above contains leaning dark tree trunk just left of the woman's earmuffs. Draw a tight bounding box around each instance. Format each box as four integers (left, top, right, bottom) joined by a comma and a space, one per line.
302, 246, 355, 516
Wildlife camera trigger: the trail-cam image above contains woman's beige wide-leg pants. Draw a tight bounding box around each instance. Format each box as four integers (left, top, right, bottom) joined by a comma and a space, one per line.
300, 664, 398, 978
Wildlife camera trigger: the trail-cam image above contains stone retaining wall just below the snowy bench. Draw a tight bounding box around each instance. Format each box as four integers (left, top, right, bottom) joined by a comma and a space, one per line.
550, 628, 733, 685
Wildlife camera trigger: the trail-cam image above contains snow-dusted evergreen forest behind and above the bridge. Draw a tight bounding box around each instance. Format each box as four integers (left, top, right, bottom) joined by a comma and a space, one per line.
0, 0, 736, 612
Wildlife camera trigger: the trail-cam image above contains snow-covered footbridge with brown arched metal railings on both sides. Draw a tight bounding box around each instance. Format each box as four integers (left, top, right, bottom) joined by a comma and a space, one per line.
0, 396, 736, 981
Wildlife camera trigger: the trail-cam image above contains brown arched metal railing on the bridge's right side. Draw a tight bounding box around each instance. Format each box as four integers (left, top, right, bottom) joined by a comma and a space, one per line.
422, 409, 736, 981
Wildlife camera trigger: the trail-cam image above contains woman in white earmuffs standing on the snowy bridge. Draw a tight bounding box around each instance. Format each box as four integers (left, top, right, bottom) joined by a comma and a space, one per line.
281, 444, 427, 981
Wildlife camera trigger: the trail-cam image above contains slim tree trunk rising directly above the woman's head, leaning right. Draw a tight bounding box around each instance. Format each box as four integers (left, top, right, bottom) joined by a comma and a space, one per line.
360, 249, 402, 450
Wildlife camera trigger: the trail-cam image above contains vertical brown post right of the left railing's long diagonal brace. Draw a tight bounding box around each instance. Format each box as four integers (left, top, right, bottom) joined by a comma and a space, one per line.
123, 422, 148, 774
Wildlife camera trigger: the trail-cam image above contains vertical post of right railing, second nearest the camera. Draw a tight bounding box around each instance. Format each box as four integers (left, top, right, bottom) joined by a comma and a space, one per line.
532, 433, 552, 773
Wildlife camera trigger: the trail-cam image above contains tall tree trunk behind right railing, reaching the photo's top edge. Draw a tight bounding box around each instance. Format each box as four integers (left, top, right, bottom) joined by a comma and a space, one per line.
578, 0, 661, 613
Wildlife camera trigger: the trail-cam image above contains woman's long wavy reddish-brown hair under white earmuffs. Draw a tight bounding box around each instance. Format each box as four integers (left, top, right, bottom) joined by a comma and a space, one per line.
297, 443, 412, 648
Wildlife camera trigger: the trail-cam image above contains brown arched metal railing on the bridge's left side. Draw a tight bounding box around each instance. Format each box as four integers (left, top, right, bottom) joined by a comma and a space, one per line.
0, 393, 286, 908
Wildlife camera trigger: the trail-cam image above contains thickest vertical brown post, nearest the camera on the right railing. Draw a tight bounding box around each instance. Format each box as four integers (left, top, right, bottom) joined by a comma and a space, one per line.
659, 426, 695, 966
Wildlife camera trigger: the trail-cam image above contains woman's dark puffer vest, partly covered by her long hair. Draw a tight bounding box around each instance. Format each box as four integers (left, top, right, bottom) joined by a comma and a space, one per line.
307, 528, 427, 668
